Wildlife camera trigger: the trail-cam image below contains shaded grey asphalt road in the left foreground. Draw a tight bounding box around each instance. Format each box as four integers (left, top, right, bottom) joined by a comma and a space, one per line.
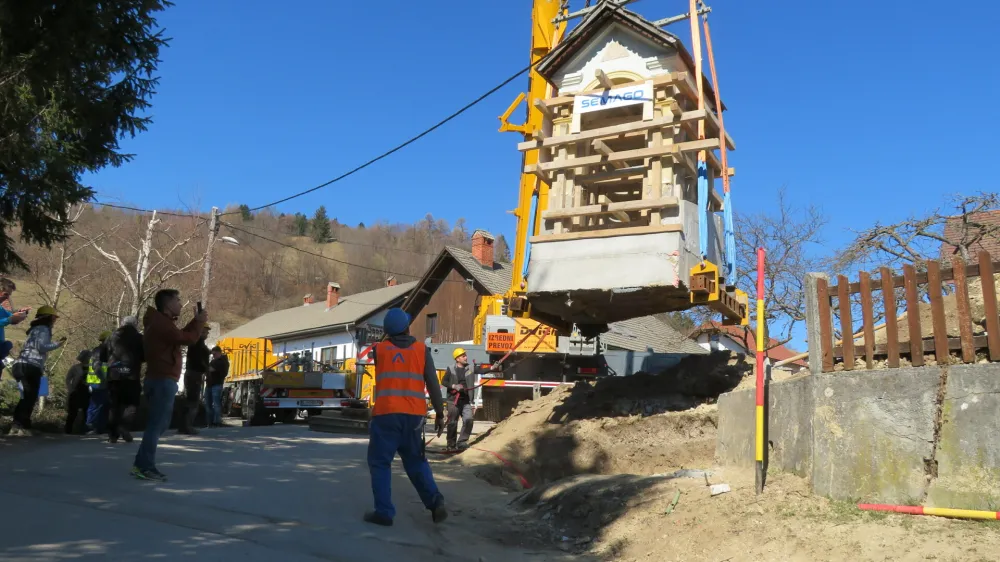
0, 425, 569, 562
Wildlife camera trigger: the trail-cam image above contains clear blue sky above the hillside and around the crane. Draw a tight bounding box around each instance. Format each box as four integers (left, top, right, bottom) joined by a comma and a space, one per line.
88, 0, 1000, 258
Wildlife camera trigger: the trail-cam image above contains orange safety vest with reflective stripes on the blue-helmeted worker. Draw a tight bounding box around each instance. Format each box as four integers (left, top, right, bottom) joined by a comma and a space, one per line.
372, 336, 427, 417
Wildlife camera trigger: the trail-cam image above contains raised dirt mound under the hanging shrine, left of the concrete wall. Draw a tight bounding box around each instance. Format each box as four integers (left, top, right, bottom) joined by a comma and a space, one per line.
452, 352, 745, 489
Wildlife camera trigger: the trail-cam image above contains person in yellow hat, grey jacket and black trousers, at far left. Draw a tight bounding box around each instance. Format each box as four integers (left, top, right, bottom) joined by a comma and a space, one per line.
10, 305, 66, 436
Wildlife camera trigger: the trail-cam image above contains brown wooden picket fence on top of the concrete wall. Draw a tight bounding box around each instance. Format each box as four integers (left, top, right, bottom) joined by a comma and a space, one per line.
809, 252, 1000, 372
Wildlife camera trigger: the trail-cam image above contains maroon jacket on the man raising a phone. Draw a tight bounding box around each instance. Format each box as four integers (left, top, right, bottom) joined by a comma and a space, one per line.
142, 307, 204, 381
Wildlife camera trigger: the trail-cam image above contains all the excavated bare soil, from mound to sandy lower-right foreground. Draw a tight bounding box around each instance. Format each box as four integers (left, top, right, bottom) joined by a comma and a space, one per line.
445, 353, 1000, 562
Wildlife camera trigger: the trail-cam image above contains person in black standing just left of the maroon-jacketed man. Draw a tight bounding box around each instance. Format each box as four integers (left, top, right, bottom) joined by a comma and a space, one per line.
108, 316, 144, 443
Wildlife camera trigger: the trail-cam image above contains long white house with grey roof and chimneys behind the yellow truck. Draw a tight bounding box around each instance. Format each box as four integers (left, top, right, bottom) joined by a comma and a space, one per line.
225, 277, 416, 368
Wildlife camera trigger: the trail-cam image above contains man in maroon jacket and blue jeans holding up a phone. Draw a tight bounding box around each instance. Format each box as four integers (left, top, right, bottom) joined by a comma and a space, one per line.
132, 289, 208, 482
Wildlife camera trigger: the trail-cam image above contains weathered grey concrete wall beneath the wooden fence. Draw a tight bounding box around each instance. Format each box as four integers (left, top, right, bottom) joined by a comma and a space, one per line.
716, 364, 1000, 510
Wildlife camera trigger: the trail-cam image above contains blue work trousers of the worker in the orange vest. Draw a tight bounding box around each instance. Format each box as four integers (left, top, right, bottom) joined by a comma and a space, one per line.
368, 414, 444, 519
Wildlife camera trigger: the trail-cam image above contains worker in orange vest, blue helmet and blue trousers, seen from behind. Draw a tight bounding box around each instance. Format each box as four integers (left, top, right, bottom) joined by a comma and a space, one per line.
364, 308, 448, 527
